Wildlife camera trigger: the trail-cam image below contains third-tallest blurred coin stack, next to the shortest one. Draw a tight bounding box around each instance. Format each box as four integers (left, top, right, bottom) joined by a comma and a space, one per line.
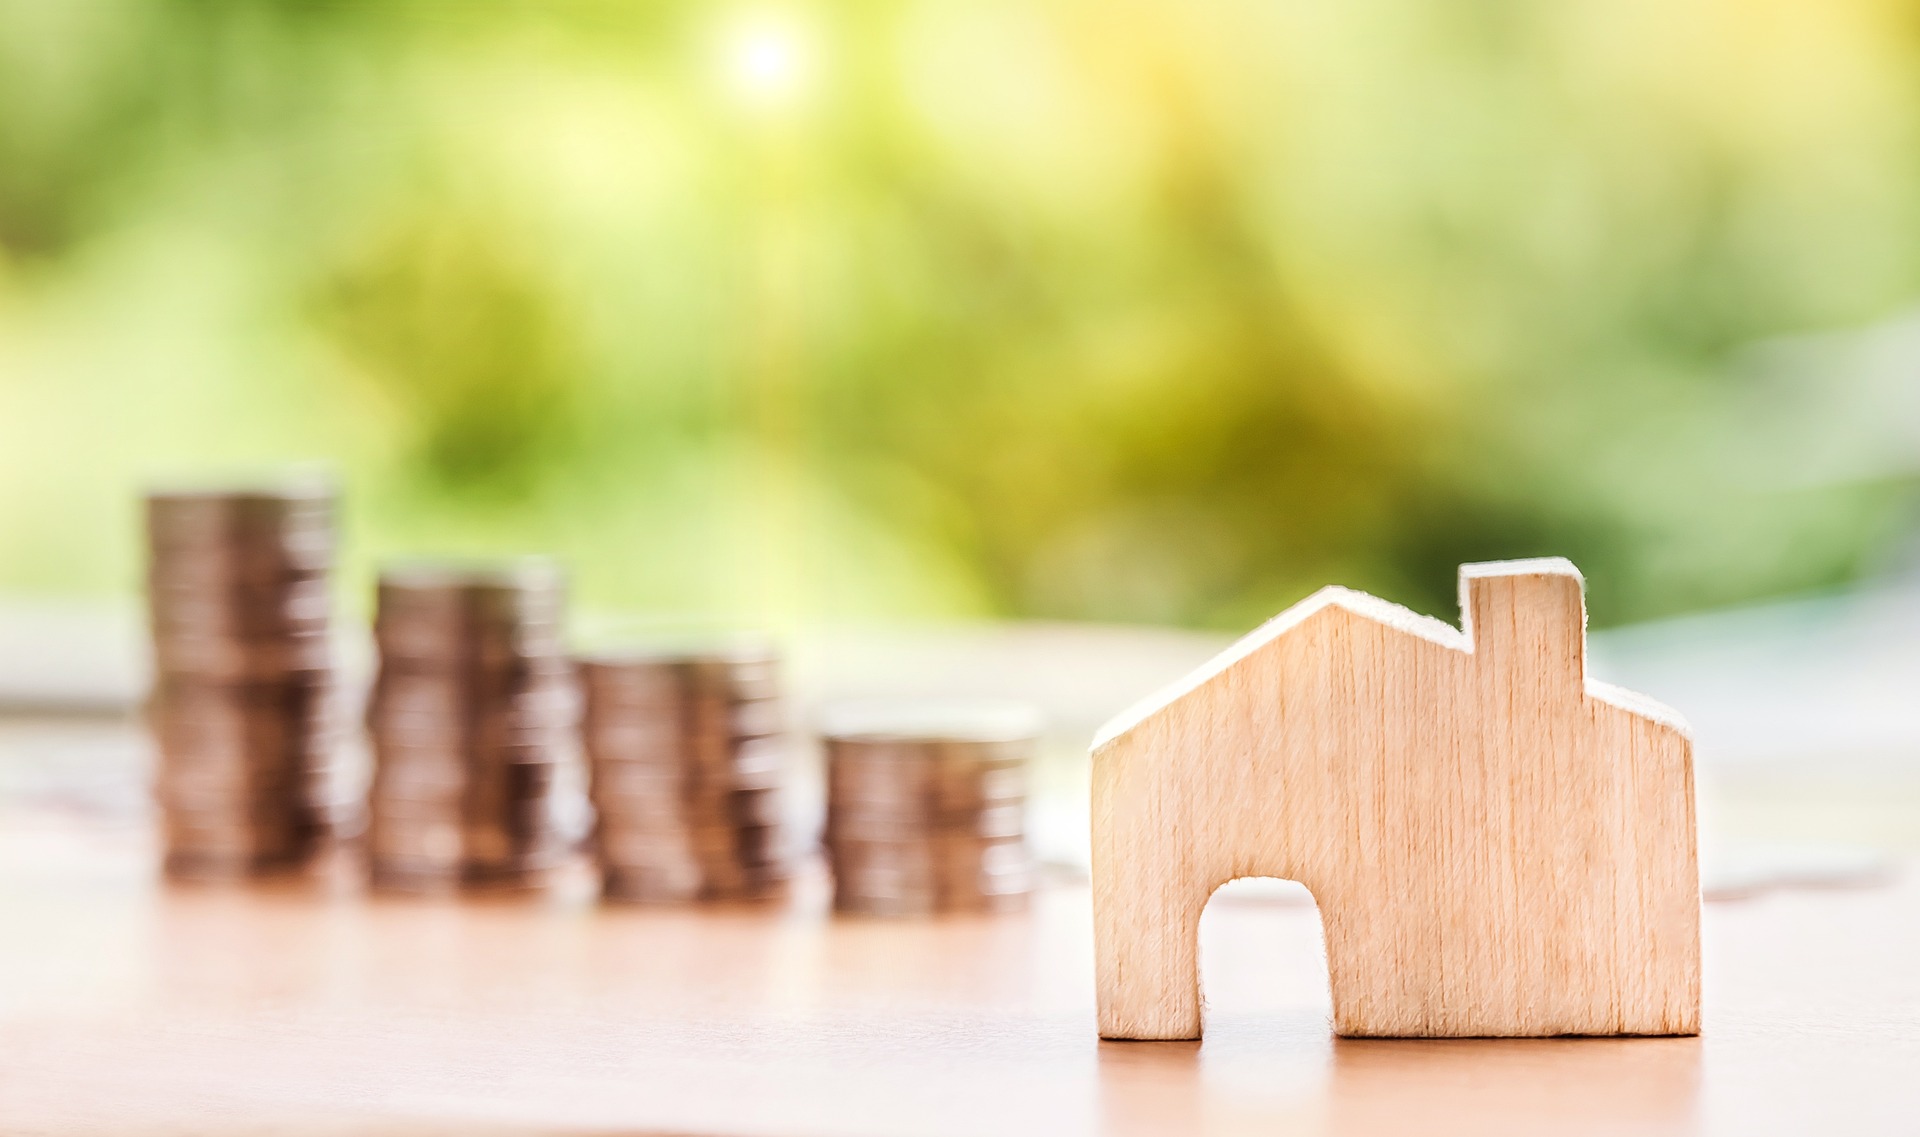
580, 643, 787, 903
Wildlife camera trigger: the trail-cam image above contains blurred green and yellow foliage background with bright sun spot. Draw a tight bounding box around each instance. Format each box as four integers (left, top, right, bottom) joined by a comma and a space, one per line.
0, 0, 1920, 628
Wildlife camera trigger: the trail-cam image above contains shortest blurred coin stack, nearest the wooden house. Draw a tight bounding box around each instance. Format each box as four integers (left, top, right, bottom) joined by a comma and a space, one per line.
822, 705, 1039, 916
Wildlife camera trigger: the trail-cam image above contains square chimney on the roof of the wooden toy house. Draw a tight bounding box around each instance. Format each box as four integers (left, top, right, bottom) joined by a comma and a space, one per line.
1459, 557, 1586, 693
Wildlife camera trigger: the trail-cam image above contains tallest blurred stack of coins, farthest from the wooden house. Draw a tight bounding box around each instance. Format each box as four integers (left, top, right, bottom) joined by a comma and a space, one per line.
146, 482, 355, 878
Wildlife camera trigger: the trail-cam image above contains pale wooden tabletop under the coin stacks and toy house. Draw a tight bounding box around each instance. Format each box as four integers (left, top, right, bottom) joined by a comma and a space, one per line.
0, 810, 1920, 1137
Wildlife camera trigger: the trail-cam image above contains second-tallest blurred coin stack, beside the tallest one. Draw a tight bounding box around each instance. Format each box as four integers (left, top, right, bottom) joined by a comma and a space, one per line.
367, 559, 576, 891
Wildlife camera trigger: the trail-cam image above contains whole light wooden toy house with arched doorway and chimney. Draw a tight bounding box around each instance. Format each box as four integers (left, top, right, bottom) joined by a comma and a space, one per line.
1092, 559, 1699, 1039
